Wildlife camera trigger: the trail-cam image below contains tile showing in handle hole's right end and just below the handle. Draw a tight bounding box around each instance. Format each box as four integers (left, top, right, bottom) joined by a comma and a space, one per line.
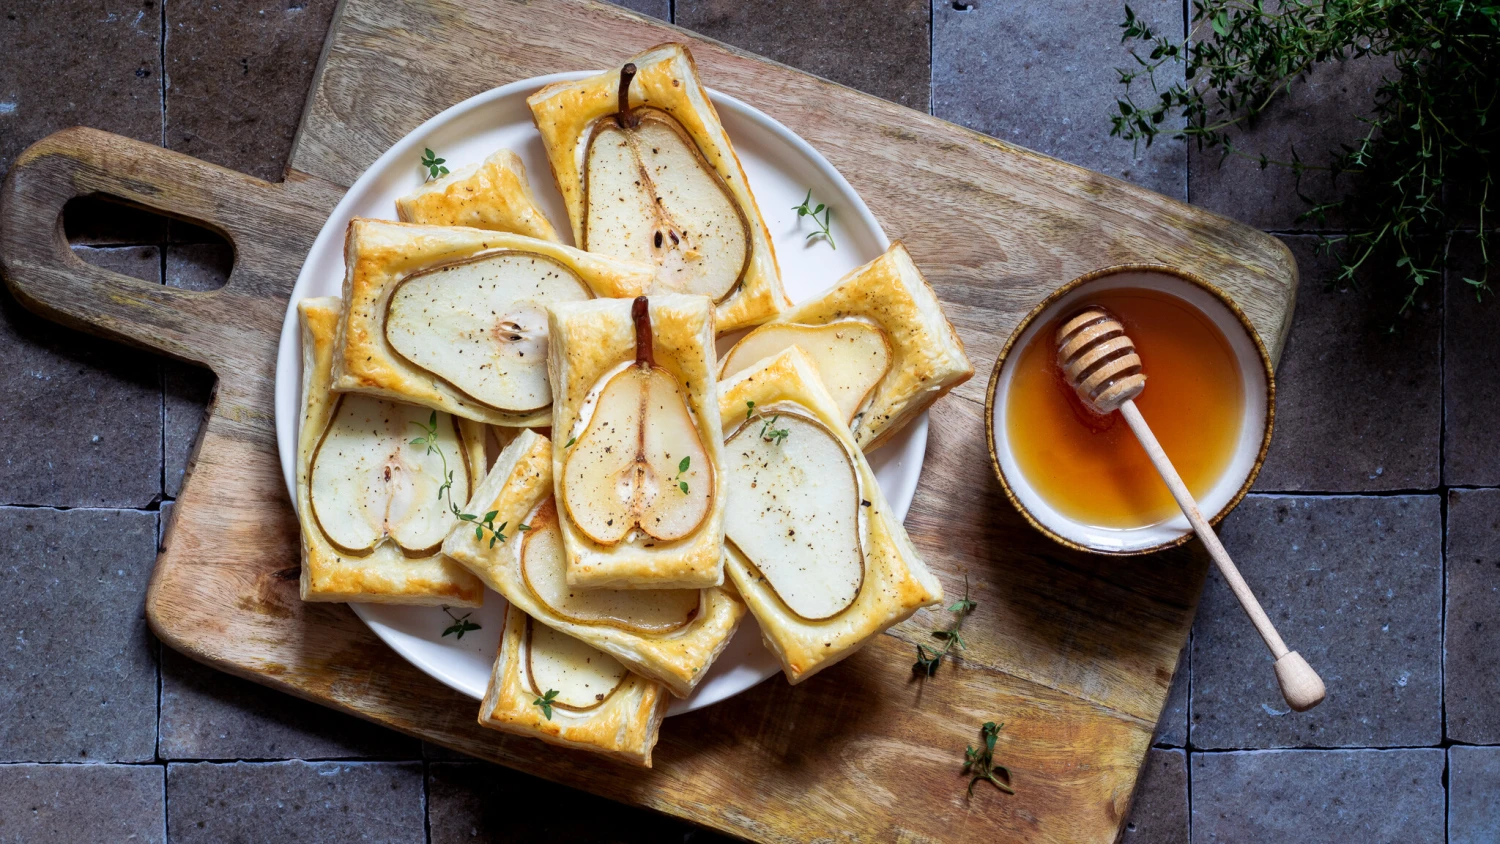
162, 243, 234, 498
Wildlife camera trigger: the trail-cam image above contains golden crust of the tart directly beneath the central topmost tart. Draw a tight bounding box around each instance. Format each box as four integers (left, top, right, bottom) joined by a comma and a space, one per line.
443, 430, 746, 697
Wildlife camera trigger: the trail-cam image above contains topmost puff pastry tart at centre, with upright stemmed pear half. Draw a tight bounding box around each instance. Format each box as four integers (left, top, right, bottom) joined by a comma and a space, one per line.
548, 294, 725, 589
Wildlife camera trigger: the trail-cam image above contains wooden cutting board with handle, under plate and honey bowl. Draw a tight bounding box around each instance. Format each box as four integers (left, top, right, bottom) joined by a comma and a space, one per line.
0, 0, 1296, 843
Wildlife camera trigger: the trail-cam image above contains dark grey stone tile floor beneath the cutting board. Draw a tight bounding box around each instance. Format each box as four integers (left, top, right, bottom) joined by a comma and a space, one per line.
0, 0, 1500, 844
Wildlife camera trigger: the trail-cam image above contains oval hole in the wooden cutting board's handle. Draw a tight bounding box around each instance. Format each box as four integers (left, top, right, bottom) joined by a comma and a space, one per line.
63, 193, 234, 291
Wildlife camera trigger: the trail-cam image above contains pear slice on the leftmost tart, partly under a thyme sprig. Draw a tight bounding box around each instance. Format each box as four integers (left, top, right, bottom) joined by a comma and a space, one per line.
309, 393, 470, 558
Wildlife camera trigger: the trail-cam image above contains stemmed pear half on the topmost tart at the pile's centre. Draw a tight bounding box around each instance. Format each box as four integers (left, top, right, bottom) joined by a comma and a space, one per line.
563, 297, 714, 546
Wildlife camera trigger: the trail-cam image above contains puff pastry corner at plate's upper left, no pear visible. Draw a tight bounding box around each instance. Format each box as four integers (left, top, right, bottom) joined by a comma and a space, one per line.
396, 150, 558, 241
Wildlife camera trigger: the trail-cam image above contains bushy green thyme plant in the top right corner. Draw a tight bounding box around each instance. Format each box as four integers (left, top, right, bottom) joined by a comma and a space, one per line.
1110, 0, 1500, 310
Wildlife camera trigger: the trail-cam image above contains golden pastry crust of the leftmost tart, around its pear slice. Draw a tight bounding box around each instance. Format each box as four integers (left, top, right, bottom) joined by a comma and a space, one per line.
297, 297, 485, 607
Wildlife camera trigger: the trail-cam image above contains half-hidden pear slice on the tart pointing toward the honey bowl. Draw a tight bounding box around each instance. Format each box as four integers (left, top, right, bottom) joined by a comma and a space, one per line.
719, 319, 891, 424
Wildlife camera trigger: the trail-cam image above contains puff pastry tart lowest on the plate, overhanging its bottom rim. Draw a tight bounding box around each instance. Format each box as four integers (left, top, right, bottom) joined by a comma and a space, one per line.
479, 606, 672, 768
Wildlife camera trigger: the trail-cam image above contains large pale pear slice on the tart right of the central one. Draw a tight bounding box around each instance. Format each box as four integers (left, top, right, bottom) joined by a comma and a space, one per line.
725, 402, 864, 621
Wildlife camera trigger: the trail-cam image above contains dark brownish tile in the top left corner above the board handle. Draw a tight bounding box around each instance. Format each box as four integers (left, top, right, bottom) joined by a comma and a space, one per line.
0, 0, 162, 174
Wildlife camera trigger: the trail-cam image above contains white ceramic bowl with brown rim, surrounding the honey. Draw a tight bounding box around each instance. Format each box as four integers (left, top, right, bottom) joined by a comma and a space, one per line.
984, 264, 1275, 555
